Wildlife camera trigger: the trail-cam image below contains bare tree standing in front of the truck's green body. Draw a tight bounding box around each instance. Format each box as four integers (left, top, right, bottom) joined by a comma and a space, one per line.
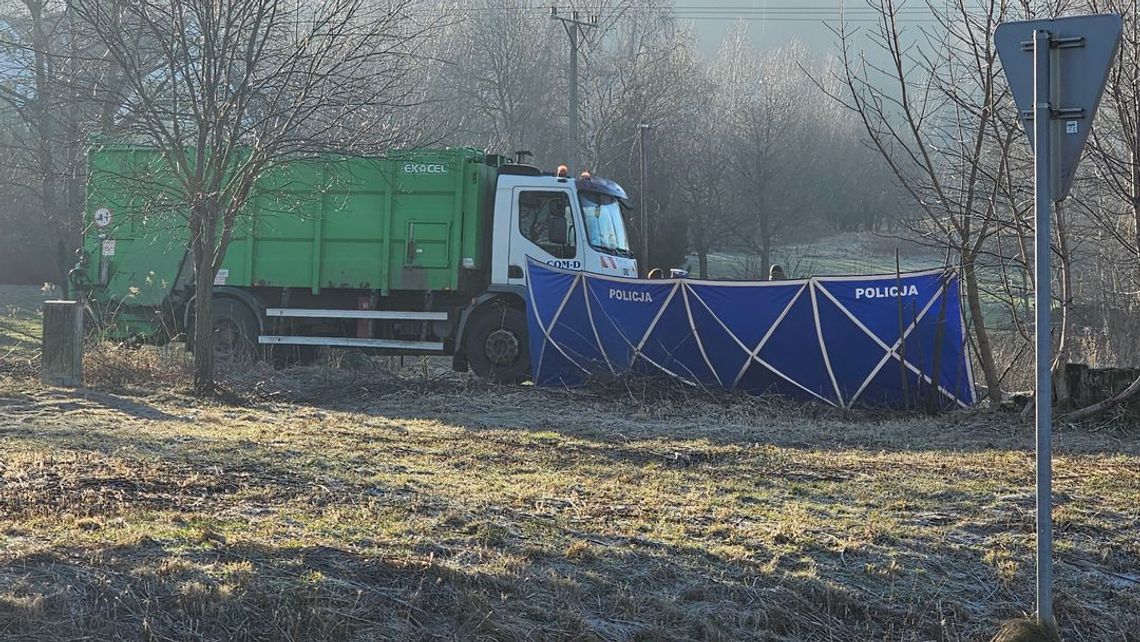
74, 0, 426, 393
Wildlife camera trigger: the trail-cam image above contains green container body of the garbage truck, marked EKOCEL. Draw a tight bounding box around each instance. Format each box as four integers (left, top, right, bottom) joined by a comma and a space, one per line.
84, 146, 503, 338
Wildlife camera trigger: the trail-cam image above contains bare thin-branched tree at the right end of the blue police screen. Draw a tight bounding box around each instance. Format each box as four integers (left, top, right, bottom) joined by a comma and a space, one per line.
820, 0, 1026, 404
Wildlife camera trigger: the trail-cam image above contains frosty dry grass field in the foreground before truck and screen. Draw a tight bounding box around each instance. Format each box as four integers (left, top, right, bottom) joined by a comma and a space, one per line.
0, 287, 1140, 642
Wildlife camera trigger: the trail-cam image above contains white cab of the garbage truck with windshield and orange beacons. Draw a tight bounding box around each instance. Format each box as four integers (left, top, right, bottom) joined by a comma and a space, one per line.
491, 165, 637, 287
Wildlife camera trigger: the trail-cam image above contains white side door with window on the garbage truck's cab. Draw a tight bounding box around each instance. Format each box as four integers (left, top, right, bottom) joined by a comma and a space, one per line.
507, 187, 581, 284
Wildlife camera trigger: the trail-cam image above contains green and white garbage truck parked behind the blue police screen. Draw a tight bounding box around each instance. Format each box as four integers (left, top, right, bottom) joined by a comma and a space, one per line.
71, 145, 637, 382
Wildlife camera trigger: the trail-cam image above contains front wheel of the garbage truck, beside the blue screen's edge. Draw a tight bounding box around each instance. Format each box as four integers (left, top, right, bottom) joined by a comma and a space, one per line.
464, 306, 530, 383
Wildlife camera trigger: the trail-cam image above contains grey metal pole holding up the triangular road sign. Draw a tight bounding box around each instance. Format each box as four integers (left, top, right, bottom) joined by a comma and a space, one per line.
1033, 30, 1053, 626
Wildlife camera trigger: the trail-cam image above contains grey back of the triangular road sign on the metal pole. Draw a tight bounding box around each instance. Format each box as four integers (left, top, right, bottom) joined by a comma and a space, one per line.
994, 14, 1123, 201
